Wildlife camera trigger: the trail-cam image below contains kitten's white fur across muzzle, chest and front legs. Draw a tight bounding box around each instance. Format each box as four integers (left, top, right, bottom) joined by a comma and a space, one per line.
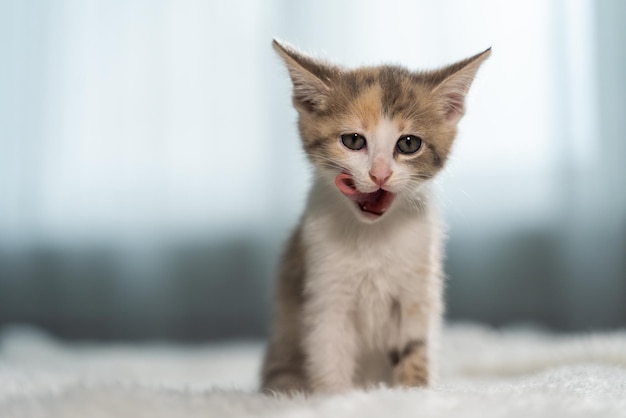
302, 116, 442, 391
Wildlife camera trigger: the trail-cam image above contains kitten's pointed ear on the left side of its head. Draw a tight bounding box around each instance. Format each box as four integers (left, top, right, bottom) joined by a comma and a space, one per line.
272, 39, 339, 112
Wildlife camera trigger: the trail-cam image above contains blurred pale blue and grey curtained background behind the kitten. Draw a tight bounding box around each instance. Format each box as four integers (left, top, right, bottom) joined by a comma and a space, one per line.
0, 0, 626, 340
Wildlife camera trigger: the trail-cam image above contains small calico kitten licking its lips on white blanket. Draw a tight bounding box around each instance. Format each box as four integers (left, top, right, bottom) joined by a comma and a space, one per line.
262, 41, 490, 392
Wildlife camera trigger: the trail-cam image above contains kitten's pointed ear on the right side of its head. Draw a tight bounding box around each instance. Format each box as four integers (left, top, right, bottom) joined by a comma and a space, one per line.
431, 48, 491, 124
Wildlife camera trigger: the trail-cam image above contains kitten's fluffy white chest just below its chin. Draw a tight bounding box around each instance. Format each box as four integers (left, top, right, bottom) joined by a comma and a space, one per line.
304, 212, 432, 324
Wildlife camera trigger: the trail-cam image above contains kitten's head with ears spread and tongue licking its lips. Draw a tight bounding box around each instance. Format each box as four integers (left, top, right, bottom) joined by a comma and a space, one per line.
273, 41, 490, 222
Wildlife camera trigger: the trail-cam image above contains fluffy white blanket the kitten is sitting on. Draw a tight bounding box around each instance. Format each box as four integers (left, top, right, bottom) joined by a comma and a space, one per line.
0, 325, 626, 418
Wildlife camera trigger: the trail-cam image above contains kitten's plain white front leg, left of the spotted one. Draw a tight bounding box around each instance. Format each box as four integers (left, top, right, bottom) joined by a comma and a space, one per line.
303, 297, 357, 392
